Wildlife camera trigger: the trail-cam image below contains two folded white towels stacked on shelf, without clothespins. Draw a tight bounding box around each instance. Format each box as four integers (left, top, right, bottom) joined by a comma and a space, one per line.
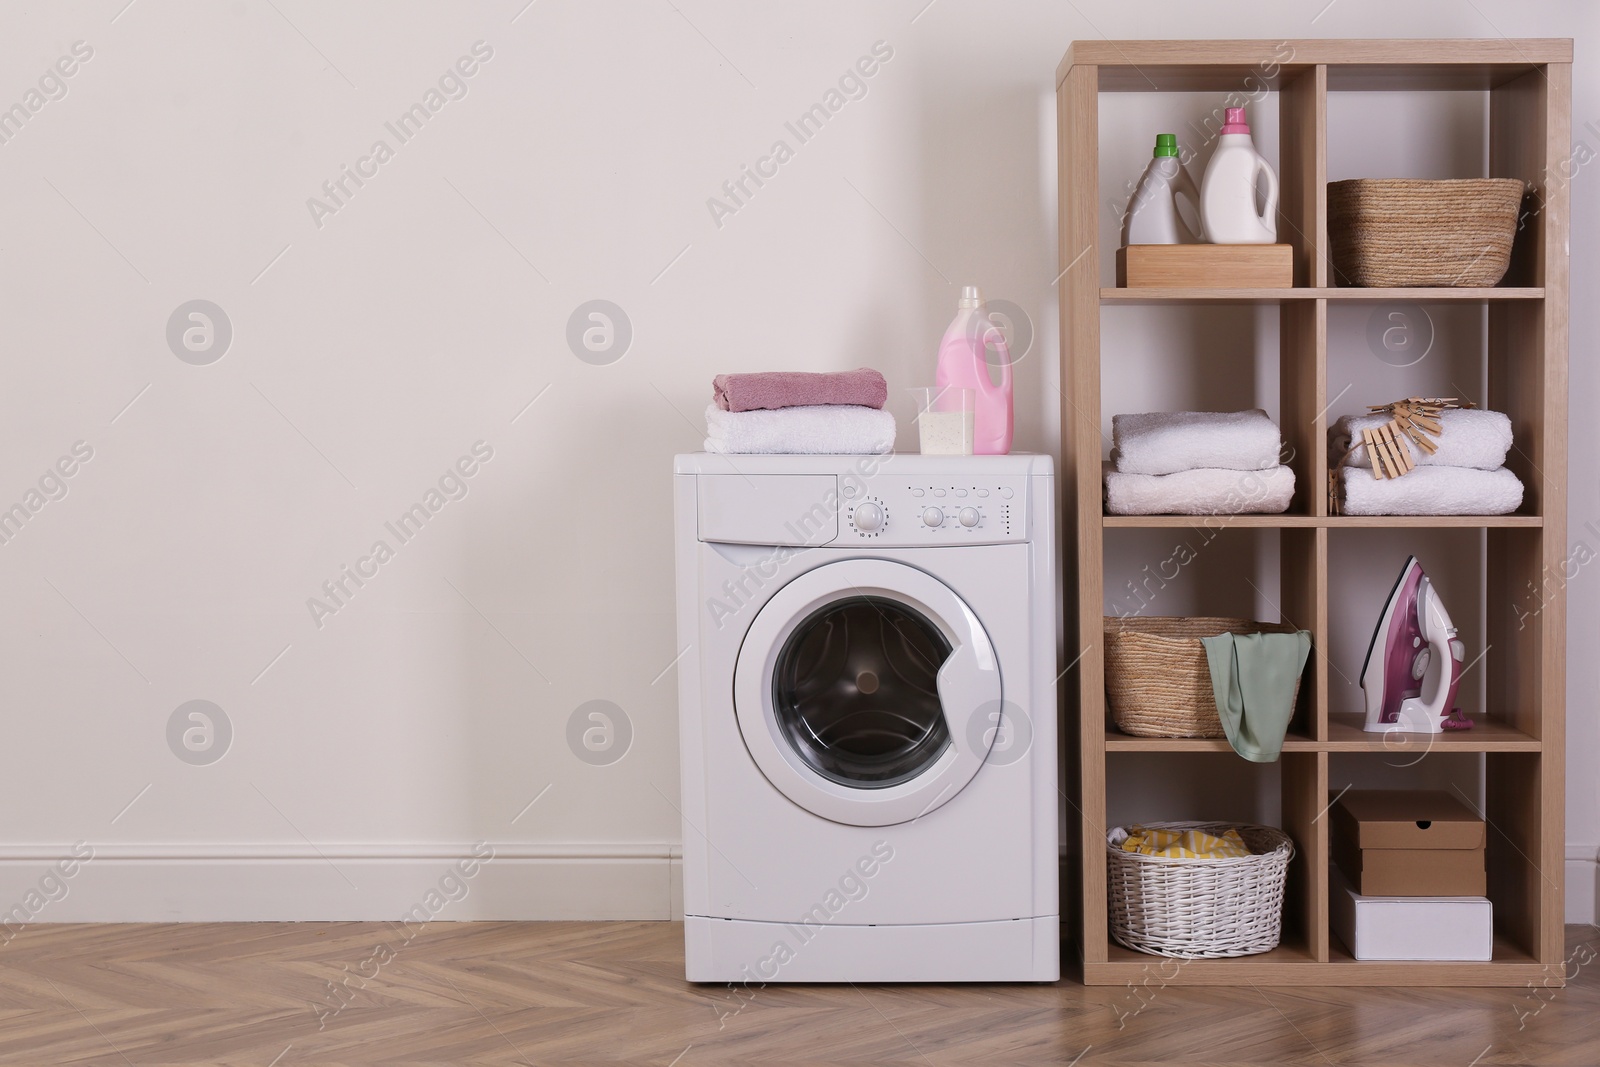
1106, 408, 1294, 515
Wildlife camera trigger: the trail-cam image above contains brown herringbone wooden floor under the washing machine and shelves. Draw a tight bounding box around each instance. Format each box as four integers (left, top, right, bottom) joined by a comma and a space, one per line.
0, 923, 1600, 1067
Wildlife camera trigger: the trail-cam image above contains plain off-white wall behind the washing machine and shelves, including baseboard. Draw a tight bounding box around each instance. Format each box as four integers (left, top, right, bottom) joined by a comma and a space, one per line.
0, 0, 1600, 920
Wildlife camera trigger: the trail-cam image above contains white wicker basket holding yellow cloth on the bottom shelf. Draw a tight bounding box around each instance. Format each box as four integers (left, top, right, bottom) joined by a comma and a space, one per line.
1106, 822, 1294, 960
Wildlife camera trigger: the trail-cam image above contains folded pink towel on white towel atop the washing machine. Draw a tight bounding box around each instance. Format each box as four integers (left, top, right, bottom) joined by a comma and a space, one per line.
706, 368, 894, 456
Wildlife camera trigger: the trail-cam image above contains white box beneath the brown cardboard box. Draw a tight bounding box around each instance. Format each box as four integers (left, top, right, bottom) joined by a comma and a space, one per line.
1328, 870, 1494, 961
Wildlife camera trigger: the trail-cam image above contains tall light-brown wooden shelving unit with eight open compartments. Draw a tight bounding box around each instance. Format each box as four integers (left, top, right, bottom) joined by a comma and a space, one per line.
1056, 40, 1573, 985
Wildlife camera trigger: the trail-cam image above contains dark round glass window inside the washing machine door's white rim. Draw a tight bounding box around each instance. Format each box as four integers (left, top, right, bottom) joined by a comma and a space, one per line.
773, 595, 954, 789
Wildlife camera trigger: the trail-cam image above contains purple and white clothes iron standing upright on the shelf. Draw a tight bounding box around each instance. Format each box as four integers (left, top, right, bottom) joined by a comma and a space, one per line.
1362, 555, 1472, 734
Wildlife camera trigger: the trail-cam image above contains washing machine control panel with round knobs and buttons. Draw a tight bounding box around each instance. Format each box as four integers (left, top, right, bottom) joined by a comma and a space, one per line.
840, 475, 1029, 547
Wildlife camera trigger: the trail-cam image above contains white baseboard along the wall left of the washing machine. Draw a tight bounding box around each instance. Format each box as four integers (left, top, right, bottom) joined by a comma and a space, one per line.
0, 843, 683, 942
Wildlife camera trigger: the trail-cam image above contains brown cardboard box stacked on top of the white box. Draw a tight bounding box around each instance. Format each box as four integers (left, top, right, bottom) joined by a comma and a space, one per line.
1333, 789, 1486, 897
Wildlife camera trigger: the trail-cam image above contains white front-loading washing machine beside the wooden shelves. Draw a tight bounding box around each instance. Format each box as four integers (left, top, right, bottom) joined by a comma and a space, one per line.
674, 453, 1061, 984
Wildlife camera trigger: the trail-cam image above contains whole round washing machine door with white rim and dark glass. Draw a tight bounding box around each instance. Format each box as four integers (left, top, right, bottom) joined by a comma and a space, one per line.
733, 560, 1002, 825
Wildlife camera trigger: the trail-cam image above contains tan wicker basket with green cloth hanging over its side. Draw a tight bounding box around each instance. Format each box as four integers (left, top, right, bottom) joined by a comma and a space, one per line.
1106, 616, 1299, 737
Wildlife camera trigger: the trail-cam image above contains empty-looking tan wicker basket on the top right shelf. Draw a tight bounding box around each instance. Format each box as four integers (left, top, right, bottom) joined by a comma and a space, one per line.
1328, 178, 1523, 288
